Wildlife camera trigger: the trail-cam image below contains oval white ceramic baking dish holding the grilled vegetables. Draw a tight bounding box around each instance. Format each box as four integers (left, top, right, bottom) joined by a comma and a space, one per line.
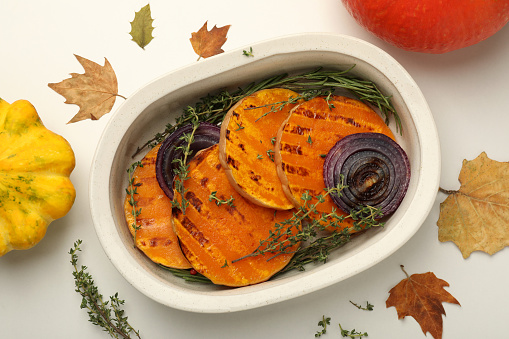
90, 33, 440, 313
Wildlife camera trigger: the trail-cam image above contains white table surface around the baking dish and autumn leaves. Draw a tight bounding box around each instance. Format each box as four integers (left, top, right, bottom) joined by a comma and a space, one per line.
0, 0, 509, 339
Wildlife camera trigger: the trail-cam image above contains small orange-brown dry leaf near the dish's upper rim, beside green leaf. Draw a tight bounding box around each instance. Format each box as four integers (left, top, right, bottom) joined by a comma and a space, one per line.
189, 21, 230, 60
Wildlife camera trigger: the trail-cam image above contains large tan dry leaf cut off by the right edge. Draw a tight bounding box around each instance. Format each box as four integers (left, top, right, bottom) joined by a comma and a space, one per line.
437, 152, 509, 258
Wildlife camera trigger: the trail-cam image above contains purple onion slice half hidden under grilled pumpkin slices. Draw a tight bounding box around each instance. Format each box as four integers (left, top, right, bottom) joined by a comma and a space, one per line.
156, 122, 221, 199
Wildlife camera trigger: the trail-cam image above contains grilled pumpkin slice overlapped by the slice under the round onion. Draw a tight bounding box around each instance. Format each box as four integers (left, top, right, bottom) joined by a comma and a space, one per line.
219, 88, 298, 210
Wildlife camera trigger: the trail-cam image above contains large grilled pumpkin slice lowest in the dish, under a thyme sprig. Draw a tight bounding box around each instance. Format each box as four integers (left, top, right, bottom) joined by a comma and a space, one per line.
173, 145, 298, 287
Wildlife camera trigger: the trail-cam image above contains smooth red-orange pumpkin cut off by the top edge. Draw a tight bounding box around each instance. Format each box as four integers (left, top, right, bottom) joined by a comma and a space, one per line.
342, 0, 509, 54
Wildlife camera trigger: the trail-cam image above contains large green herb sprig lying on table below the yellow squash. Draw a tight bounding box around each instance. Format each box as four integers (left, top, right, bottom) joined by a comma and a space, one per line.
69, 239, 141, 339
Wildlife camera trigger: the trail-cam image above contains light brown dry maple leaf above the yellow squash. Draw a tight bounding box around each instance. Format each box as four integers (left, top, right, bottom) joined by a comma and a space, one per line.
48, 55, 125, 123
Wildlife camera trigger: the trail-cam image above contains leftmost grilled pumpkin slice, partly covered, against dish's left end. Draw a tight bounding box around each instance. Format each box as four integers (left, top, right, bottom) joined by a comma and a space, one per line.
124, 144, 191, 269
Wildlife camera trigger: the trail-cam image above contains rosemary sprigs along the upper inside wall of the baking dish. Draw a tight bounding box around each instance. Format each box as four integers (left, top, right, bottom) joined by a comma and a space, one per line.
133, 65, 402, 157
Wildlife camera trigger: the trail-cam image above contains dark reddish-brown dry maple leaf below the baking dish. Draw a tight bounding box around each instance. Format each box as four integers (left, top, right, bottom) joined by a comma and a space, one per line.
385, 265, 460, 339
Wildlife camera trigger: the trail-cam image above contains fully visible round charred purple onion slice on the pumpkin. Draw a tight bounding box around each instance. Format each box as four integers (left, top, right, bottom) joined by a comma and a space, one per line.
323, 133, 410, 216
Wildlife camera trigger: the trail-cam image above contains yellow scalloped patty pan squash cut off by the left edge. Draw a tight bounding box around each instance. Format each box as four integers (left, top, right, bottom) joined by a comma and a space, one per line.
0, 99, 76, 256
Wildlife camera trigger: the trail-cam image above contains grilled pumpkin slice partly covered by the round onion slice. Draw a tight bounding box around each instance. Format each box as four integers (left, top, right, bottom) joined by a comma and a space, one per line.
275, 96, 394, 230
